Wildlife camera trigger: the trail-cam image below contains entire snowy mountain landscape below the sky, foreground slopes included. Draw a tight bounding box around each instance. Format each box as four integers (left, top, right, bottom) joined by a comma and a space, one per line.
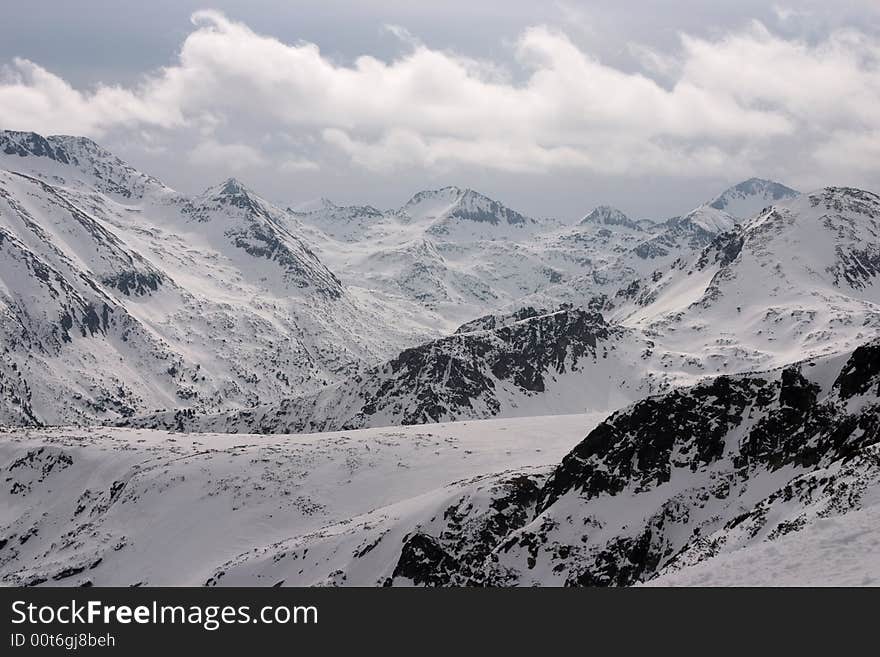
0, 131, 880, 586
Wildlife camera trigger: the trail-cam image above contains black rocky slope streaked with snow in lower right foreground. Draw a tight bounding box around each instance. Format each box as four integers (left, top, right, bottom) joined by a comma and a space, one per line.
370, 342, 880, 586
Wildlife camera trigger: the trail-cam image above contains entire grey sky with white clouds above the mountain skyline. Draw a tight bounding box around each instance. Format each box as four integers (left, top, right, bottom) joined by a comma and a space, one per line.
0, 0, 880, 219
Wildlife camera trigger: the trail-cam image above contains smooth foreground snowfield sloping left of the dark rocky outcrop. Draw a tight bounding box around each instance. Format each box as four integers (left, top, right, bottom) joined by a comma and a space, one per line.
0, 416, 600, 586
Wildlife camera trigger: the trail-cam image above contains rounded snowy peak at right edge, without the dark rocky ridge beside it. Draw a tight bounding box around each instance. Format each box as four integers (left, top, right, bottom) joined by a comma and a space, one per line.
611, 188, 880, 369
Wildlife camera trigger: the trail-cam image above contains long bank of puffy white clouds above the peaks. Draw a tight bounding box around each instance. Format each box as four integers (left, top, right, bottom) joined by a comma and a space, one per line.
0, 11, 880, 182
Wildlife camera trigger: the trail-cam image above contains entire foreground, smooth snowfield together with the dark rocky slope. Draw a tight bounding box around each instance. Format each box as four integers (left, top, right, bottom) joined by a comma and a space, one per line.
0, 342, 880, 586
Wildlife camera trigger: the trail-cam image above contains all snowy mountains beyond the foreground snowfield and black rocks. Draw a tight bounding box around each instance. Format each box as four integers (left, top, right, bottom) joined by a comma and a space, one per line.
0, 133, 880, 432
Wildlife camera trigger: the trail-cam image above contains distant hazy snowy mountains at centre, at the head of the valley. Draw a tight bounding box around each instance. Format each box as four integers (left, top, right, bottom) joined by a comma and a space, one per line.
290, 187, 564, 324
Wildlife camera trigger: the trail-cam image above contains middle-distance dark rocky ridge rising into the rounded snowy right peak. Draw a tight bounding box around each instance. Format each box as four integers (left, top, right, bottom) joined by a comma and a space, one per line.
128, 188, 880, 433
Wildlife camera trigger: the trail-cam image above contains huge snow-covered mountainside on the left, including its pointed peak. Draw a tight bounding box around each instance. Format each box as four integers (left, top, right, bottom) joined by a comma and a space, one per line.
0, 132, 430, 423
